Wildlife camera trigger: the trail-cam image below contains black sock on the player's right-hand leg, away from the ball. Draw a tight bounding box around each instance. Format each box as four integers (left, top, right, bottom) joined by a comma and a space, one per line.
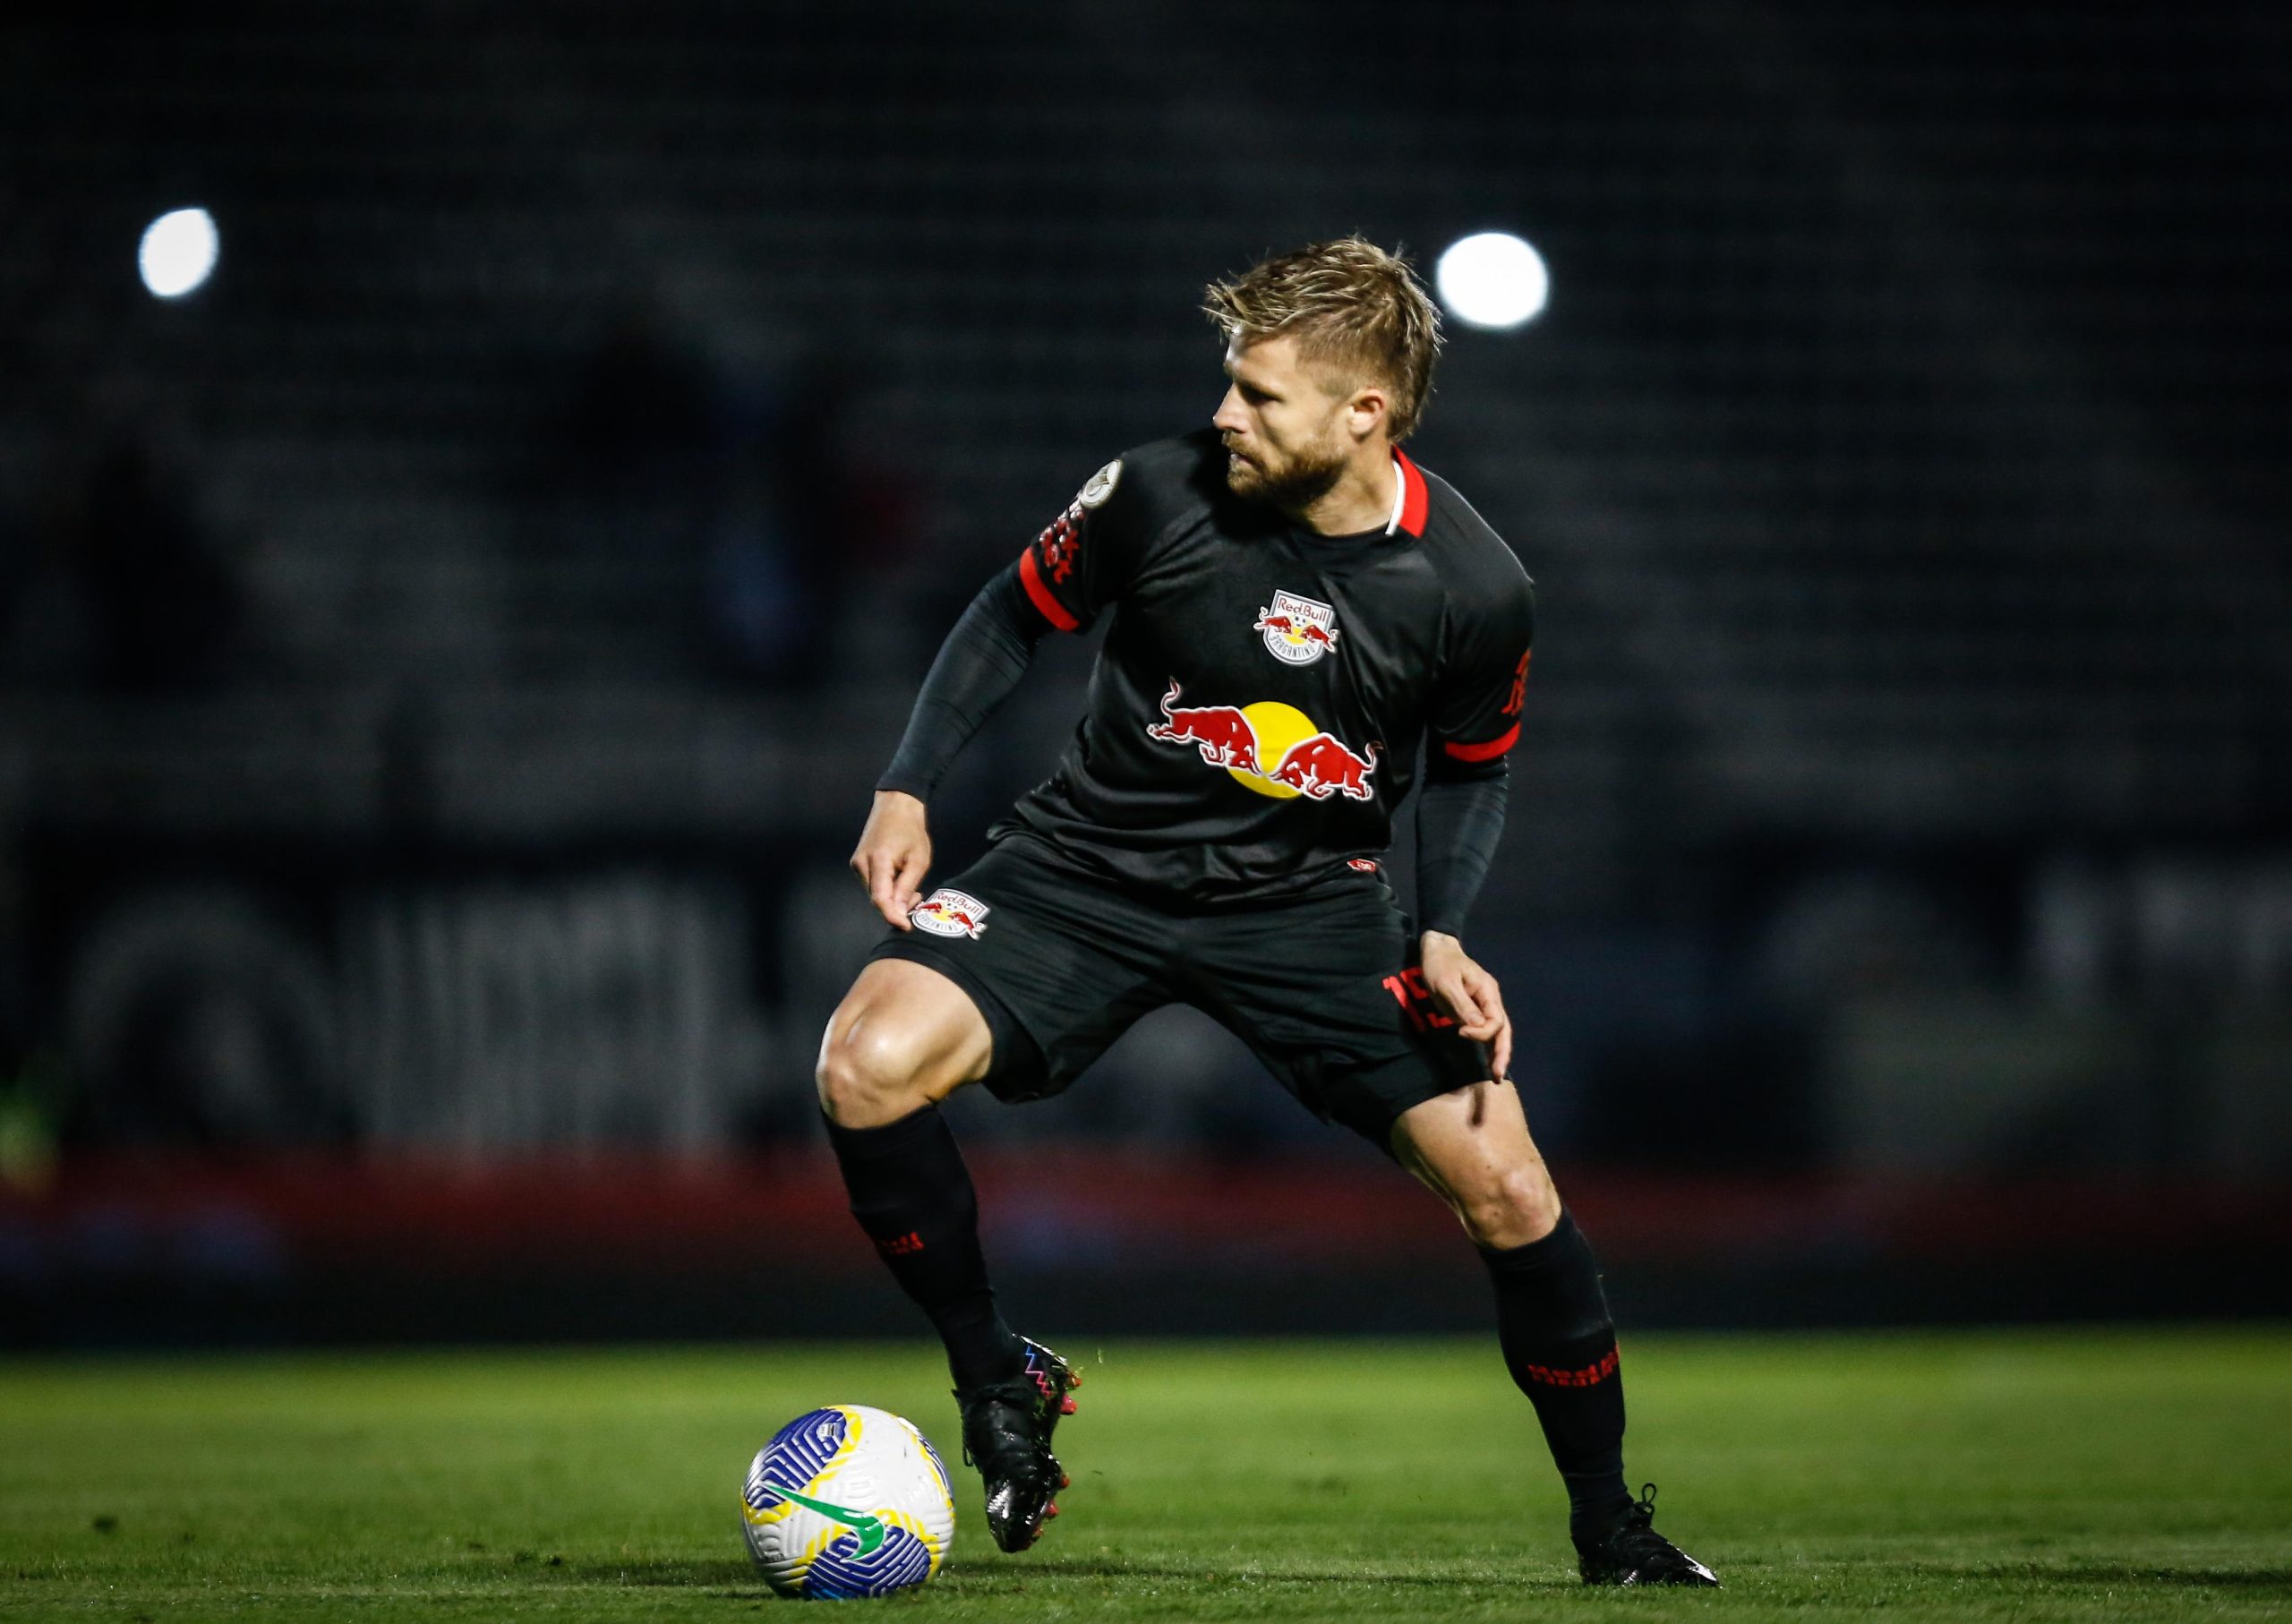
1481, 1211, 1632, 1534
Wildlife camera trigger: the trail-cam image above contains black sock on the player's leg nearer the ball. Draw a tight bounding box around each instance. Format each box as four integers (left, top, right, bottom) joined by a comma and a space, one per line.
827, 1107, 1027, 1388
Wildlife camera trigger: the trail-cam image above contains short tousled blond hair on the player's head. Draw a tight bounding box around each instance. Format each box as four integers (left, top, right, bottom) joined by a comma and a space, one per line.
1201, 236, 1441, 444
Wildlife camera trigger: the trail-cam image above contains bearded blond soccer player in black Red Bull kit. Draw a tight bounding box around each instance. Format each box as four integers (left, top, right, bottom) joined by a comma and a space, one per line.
818, 238, 1719, 1586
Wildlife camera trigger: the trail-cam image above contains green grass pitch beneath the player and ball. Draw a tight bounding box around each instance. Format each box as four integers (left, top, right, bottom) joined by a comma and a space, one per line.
0, 1331, 2292, 1621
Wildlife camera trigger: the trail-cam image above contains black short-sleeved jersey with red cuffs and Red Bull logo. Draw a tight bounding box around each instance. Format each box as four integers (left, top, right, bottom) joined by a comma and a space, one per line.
990, 431, 1535, 902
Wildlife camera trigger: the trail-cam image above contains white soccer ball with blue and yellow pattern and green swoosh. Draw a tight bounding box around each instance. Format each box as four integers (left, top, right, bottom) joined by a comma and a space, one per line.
740, 1404, 956, 1599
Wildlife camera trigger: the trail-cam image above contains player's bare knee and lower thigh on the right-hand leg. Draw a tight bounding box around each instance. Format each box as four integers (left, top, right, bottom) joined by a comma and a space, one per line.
1391, 1081, 1561, 1248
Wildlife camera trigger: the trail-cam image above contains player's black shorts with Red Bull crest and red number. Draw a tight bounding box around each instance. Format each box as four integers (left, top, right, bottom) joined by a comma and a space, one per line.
871, 833, 1487, 1152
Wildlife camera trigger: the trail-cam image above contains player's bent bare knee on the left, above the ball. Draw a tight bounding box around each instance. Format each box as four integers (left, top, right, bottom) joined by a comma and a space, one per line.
816, 957, 995, 1127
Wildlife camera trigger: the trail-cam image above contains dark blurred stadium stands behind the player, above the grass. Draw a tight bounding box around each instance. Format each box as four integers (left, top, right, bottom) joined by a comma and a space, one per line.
0, 0, 2292, 1345
